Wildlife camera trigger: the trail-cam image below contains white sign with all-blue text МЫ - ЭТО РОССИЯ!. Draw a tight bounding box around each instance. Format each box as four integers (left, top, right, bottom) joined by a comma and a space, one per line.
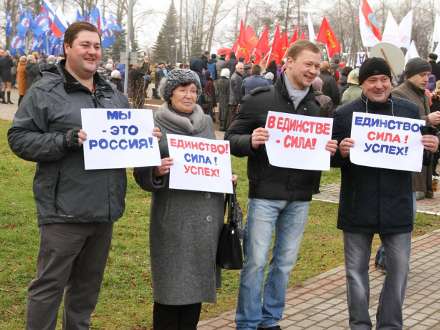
81, 108, 161, 170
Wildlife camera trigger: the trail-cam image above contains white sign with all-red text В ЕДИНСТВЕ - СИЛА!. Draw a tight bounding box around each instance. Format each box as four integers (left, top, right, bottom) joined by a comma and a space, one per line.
266, 111, 333, 171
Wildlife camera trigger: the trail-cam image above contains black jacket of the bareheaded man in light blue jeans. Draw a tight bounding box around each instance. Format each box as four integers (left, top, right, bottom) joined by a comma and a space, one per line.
225, 75, 324, 201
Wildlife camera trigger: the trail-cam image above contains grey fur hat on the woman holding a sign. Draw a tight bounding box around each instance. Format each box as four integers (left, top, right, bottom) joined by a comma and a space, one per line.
159, 69, 202, 102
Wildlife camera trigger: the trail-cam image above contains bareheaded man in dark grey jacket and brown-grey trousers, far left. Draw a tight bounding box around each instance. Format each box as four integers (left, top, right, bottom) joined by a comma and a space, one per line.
8, 22, 129, 330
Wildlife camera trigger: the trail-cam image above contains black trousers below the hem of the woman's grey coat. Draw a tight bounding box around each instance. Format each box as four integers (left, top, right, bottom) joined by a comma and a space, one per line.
153, 302, 202, 330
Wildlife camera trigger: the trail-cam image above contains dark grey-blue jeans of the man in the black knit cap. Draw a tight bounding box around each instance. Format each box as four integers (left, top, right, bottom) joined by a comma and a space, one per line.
344, 231, 411, 330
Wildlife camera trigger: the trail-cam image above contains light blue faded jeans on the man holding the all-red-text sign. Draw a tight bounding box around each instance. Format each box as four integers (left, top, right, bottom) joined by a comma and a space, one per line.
235, 199, 309, 330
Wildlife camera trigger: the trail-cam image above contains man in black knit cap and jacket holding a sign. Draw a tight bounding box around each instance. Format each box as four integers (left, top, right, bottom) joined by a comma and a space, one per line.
333, 57, 438, 330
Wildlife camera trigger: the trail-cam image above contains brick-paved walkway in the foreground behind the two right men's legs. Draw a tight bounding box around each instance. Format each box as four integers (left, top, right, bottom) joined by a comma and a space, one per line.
198, 230, 440, 330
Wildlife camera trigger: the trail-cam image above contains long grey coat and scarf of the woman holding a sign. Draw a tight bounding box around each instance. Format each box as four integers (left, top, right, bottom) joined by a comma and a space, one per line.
134, 104, 223, 305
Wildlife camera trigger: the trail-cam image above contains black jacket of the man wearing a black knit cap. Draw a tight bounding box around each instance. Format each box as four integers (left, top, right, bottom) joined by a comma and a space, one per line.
332, 95, 419, 234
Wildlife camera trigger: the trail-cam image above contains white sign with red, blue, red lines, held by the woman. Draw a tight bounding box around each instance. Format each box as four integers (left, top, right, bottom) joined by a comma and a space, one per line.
167, 134, 232, 194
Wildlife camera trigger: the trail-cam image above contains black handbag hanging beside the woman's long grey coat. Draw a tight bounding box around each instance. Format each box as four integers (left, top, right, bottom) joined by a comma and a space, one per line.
217, 191, 243, 269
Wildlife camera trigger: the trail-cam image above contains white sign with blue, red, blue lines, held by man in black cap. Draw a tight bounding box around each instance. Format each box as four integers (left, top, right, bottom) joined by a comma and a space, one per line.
350, 112, 425, 172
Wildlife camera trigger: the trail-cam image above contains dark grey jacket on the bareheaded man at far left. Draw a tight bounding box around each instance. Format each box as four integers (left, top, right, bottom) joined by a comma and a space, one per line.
8, 63, 129, 225
